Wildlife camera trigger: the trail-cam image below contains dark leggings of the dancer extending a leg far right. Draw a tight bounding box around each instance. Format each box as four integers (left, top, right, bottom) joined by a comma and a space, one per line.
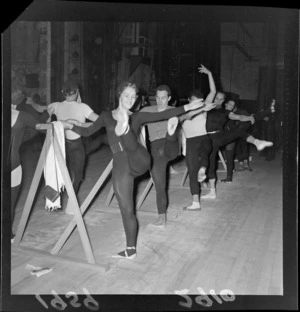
208, 121, 251, 179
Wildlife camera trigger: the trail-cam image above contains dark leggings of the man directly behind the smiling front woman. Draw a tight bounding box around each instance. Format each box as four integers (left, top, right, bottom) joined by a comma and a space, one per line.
151, 131, 179, 214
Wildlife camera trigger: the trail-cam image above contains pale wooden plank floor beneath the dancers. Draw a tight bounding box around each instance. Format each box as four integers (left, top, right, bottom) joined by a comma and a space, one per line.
11, 138, 283, 295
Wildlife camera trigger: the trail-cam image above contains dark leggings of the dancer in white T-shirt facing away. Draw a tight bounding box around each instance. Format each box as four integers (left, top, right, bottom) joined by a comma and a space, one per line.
66, 137, 85, 194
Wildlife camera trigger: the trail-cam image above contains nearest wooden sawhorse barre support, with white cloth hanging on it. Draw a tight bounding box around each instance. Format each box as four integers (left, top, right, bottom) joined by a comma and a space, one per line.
13, 123, 112, 265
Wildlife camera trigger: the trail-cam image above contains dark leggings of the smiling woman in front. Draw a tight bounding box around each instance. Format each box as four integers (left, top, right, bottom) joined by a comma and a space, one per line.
112, 130, 151, 247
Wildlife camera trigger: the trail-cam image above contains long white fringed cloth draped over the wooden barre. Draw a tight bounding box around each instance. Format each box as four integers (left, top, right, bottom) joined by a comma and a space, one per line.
44, 121, 66, 211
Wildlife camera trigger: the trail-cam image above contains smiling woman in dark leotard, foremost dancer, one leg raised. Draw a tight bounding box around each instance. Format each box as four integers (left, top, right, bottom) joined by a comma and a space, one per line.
65, 82, 202, 259
